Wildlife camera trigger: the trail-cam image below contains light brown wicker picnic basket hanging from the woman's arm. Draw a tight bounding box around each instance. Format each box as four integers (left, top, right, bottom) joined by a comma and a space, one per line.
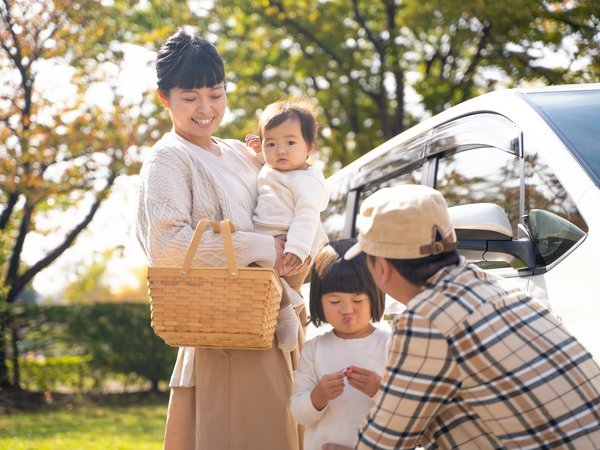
148, 220, 282, 350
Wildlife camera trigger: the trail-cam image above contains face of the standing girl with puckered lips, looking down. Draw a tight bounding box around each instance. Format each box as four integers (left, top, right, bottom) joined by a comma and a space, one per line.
321, 292, 374, 339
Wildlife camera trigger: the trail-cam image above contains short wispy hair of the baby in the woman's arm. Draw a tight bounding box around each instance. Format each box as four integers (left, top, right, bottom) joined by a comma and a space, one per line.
258, 97, 318, 149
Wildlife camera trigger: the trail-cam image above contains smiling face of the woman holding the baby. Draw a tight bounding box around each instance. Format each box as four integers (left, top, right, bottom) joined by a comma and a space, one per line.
159, 83, 227, 148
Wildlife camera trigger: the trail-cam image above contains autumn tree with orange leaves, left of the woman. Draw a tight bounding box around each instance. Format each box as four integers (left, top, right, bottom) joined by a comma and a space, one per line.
0, 0, 161, 386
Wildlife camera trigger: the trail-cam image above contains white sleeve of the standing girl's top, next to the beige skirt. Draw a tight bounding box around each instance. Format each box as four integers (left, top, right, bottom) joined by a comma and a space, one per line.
291, 338, 328, 426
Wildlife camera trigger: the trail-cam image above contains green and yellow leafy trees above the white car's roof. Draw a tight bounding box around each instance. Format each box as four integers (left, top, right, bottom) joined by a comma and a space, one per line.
193, 0, 600, 170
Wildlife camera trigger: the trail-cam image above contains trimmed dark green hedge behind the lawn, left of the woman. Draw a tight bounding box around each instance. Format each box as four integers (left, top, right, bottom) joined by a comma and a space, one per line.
8, 303, 177, 390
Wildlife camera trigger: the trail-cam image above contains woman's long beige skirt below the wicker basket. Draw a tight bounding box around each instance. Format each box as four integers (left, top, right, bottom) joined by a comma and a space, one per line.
164, 314, 306, 450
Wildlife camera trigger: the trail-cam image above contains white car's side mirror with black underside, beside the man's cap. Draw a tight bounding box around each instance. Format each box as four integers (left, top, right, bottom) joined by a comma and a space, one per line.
448, 203, 535, 268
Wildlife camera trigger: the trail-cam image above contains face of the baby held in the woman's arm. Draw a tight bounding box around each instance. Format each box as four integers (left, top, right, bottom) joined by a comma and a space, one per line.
261, 119, 313, 171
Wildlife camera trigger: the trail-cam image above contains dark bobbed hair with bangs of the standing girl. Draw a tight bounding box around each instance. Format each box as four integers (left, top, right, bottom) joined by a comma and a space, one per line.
309, 239, 385, 327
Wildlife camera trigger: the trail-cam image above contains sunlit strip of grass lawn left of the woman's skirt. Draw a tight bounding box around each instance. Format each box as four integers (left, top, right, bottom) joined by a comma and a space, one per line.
0, 394, 168, 450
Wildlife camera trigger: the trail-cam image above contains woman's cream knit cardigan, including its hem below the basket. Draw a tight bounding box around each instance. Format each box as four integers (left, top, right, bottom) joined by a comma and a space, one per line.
135, 132, 276, 386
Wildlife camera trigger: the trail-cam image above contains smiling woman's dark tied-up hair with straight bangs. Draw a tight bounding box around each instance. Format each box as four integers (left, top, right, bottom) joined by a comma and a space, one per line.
156, 28, 225, 95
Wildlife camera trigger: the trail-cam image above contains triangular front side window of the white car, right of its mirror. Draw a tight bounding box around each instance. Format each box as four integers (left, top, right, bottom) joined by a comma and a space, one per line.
525, 148, 588, 267
